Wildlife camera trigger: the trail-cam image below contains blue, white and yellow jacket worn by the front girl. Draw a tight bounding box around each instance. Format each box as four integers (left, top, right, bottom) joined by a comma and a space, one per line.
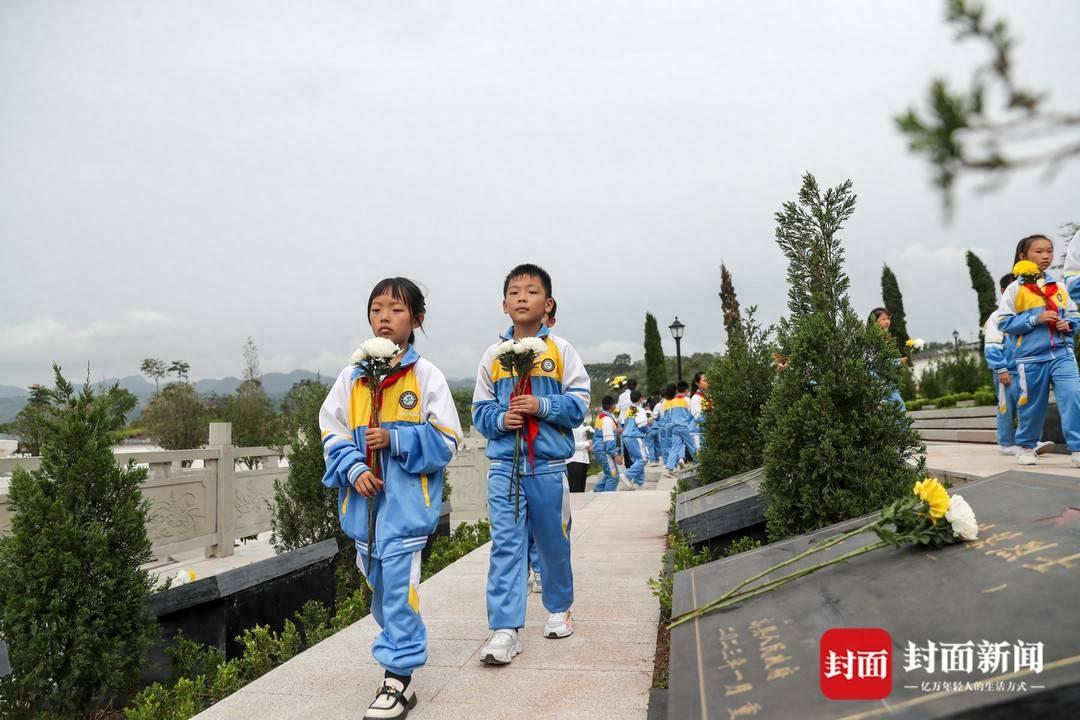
319, 345, 461, 558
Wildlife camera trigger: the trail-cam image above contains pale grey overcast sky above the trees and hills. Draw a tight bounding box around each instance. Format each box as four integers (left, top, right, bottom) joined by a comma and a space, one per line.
0, 0, 1080, 385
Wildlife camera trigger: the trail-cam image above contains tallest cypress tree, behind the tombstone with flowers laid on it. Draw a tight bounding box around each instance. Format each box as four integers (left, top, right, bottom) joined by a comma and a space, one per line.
761, 174, 923, 540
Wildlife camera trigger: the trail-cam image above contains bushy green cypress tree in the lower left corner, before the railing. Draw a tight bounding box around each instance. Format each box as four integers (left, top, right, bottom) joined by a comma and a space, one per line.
0, 366, 157, 718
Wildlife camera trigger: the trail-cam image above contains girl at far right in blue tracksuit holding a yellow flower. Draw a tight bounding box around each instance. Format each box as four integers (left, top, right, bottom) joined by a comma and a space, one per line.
998, 235, 1080, 467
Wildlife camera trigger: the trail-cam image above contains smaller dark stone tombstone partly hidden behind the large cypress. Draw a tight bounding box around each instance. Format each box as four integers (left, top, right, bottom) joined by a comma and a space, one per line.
675, 467, 767, 548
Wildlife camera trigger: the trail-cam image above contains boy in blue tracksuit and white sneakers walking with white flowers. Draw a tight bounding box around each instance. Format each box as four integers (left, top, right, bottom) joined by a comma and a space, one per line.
472, 264, 590, 665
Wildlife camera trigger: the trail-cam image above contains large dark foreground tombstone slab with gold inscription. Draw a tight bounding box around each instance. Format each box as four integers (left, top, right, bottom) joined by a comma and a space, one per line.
669, 471, 1080, 720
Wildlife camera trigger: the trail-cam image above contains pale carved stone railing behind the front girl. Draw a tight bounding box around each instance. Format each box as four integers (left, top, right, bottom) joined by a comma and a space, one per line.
0, 422, 487, 558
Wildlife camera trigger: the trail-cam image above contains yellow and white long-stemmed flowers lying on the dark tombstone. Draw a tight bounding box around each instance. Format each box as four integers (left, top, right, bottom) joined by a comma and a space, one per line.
667, 477, 978, 628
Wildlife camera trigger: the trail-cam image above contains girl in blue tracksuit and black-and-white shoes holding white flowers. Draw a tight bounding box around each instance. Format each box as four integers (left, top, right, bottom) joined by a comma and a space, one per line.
319, 277, 461, 719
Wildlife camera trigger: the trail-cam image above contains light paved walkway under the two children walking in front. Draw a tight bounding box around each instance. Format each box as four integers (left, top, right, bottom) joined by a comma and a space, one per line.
198, 468, 672, 720
